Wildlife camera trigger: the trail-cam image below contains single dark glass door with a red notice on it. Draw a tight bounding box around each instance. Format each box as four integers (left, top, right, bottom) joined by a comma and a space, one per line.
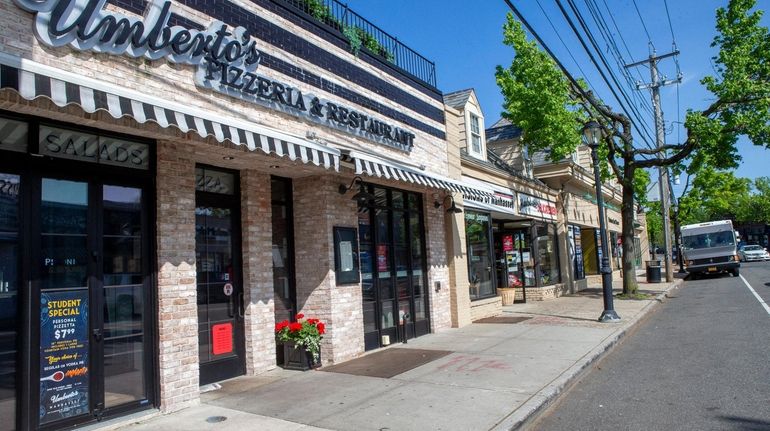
195, 168, 246, 385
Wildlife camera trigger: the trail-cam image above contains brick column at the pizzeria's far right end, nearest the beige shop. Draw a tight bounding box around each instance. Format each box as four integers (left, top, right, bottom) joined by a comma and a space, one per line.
423, 195, 452, 332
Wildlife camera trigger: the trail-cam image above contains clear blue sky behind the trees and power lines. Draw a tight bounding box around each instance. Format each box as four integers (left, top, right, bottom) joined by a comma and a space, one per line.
347, 0, 770, 194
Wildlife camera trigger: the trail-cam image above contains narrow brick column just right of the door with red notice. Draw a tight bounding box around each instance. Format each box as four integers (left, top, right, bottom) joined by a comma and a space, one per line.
240, 170, 275, 375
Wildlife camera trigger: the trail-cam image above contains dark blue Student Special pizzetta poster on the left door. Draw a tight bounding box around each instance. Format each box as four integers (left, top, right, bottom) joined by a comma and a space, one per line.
40, 289, 89, 424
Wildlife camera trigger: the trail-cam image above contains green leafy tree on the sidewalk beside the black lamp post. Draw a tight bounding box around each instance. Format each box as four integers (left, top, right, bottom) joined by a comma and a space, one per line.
496, 0, 770, 294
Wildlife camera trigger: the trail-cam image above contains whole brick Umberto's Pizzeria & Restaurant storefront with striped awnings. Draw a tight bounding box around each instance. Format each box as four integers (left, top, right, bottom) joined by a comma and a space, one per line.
0, 0, 483, 430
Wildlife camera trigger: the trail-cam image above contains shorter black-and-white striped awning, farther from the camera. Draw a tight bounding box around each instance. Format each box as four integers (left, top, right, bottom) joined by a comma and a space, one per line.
343, 151, 492, 198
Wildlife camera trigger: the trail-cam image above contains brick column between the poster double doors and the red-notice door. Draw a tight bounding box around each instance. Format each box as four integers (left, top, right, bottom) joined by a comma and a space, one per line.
157, 141, 200, 412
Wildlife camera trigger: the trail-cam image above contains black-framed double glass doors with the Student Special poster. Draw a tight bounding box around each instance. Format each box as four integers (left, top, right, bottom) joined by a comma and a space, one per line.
33, 178, 152, 427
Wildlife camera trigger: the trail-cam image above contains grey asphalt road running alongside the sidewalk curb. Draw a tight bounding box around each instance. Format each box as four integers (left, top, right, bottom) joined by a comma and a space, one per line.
531, 262, 770, 431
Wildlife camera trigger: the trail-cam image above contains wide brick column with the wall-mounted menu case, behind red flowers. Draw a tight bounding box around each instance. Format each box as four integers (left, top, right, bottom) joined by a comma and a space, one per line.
294, 176, 364, 365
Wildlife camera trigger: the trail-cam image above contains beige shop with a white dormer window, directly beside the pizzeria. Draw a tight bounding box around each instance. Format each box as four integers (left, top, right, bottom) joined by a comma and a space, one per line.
444, 89, 566, 326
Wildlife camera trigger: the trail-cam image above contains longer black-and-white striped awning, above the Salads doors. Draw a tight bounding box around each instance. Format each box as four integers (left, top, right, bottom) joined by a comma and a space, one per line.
0, 53, 340, 171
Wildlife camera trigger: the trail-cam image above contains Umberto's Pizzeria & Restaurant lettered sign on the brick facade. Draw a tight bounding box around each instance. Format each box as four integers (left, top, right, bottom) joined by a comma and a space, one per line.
14, 0, 415, 152
